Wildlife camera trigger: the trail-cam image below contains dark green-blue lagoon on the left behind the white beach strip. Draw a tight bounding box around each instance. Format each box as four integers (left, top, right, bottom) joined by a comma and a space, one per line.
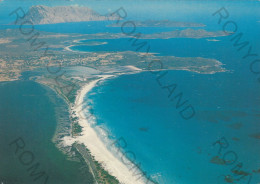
0, 81, 92, 184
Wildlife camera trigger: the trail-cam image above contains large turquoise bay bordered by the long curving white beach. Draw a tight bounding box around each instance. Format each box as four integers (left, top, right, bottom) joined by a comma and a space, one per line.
86, 71, 260, 184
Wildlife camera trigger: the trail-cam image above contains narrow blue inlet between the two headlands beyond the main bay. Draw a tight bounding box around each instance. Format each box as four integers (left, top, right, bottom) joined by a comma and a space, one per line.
71, 37, 226, 57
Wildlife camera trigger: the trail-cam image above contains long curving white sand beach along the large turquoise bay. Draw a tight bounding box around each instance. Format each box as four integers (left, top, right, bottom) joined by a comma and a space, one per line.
64, 75, 149, 184
